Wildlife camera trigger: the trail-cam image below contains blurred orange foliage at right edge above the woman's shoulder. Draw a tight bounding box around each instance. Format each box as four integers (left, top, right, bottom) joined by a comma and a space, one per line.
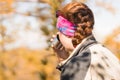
104, 27, 120, 59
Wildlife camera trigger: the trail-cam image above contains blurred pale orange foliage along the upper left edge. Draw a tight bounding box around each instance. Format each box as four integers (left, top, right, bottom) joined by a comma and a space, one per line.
0, 0, 14, 52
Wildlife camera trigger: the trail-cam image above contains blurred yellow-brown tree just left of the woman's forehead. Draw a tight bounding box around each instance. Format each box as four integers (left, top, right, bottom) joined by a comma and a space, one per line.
39, 0, 64, 36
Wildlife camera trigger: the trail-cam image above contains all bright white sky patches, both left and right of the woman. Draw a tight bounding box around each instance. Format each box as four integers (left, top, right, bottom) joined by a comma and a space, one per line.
4, 0, 120, 49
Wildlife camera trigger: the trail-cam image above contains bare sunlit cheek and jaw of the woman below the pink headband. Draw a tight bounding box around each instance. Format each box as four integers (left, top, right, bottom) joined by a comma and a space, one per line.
59, 32, 74, 50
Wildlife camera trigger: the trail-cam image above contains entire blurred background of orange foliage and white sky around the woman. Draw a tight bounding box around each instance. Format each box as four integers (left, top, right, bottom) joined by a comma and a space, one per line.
0, 0, 120, 80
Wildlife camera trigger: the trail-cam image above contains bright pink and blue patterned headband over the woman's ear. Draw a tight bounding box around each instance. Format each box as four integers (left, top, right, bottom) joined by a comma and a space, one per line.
57, 16, 76, 37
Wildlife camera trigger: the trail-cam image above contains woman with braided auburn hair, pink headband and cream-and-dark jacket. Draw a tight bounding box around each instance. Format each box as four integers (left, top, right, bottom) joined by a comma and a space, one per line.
50, 2, 120, 80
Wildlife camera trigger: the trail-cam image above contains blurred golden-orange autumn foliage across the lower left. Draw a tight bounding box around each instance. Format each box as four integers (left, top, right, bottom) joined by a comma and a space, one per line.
0, 48, 59, 80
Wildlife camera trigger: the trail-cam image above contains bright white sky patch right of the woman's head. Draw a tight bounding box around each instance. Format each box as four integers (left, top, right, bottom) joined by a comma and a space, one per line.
88, 0, 120, 42
